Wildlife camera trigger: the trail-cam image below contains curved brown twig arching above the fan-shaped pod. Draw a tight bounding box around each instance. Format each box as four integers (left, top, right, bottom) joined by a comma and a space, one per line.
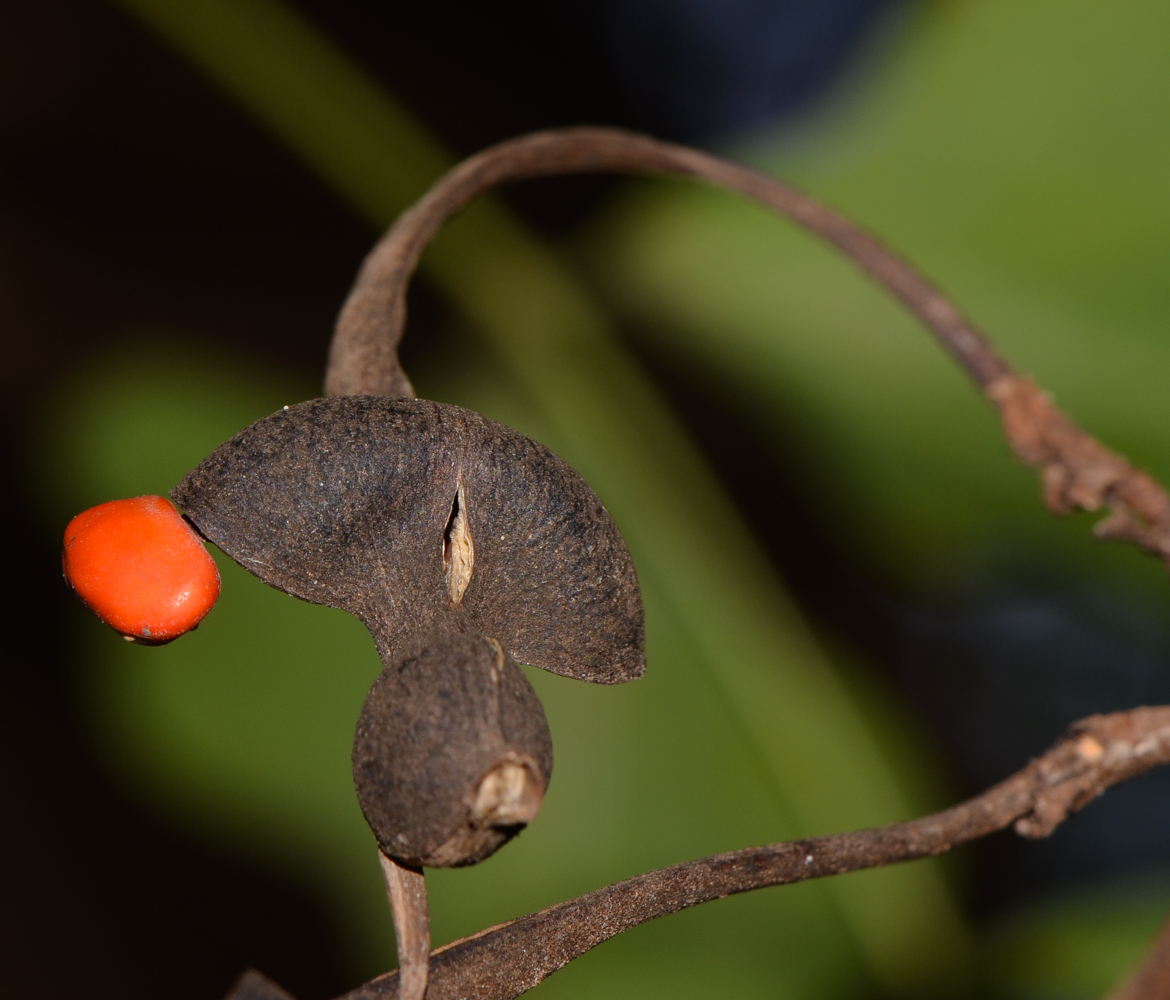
325, 129, 1170, 564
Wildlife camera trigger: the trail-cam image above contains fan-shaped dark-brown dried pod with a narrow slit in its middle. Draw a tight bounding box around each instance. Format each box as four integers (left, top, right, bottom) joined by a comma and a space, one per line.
171, 396, 645, 683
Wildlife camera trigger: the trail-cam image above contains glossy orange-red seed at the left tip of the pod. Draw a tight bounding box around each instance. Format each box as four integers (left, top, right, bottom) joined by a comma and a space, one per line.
61, 497, 220, 643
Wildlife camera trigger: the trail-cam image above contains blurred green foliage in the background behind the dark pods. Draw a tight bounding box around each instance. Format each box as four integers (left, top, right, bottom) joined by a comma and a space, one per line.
32, 0, 1170, 998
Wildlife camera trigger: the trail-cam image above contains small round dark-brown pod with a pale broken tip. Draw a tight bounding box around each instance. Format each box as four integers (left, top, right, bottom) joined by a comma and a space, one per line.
353, 633, 552, 868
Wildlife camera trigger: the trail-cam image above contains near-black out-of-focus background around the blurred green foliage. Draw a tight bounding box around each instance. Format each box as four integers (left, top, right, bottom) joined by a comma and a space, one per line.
0, 0, 1170, 1000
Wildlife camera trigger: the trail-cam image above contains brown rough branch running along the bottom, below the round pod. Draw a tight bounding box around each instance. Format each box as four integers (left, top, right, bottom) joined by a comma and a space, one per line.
269, 706, 1170, 1000
